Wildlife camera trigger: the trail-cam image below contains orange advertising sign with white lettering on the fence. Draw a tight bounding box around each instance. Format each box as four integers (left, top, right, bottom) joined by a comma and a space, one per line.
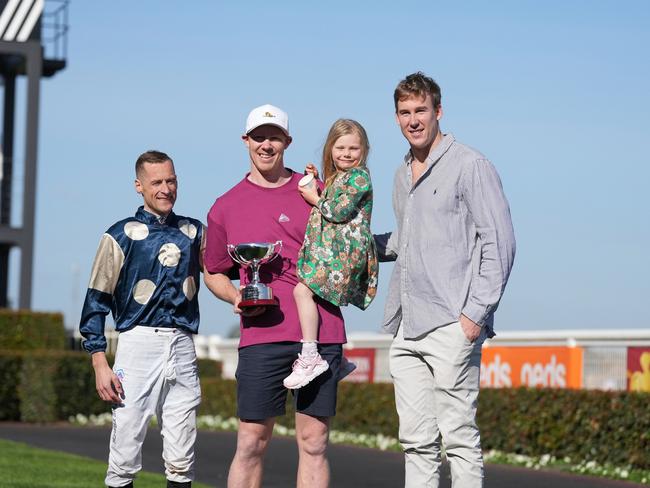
481, 346, 583, 388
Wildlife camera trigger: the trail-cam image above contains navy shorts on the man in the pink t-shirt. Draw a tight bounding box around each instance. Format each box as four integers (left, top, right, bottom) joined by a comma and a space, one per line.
236, 342, 343, 420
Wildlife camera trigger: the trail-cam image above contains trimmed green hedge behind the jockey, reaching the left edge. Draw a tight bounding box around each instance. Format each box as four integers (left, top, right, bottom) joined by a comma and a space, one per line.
0, 351, 221, 422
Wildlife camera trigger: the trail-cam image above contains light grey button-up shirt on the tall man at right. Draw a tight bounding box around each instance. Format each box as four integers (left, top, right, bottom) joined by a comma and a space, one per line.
375, 134, 515, 338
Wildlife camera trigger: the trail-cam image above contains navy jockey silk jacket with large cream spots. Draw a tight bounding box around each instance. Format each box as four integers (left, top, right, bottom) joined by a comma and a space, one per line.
79, 207, 205, 354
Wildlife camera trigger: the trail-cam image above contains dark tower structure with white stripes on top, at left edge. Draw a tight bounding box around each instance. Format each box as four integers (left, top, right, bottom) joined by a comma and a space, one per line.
0, 0, 69, 309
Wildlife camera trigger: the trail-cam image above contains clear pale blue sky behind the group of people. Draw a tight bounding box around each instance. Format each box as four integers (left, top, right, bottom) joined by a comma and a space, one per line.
7, 0, 650, 334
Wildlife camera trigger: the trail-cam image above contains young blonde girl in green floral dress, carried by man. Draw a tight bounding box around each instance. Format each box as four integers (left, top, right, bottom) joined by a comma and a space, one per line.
284, 119, 378, 389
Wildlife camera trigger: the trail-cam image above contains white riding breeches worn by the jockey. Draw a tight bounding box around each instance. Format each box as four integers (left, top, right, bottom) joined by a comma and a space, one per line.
106, 326, 201, 487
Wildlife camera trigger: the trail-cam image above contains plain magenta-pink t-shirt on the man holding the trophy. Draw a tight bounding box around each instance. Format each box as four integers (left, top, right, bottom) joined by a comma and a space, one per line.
204, 173, 346, 347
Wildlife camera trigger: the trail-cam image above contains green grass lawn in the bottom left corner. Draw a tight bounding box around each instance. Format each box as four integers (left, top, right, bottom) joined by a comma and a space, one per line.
0, 440, 208, 488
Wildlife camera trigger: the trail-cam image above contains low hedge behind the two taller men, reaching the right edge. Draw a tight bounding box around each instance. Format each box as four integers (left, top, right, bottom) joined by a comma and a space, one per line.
201, 380, 650, 469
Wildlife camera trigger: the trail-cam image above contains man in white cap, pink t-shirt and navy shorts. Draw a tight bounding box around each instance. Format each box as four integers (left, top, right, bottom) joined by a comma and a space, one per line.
204, 105, 346, 488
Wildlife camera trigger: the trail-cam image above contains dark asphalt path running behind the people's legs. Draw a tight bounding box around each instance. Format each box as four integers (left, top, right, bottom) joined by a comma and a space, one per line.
0, 422, 643, 488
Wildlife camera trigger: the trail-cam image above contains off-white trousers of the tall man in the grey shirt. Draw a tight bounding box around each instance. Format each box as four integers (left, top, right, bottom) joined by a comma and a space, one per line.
390, 322, 485, 488
